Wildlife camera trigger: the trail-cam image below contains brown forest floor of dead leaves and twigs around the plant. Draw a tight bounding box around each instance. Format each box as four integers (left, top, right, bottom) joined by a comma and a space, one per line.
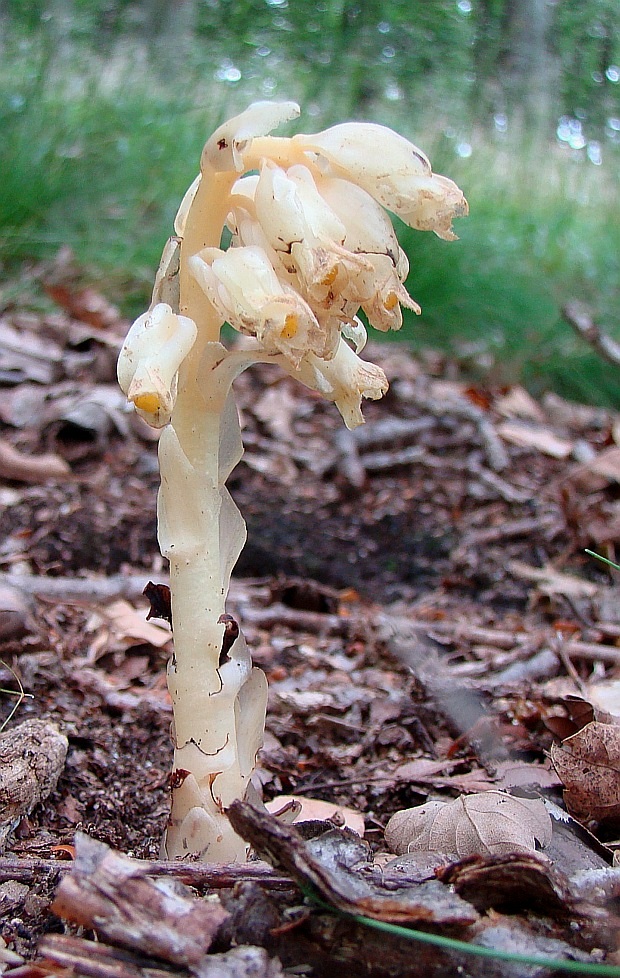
0, 270, 620, 978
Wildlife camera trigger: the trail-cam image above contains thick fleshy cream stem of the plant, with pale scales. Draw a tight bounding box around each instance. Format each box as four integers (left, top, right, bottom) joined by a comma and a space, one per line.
158, 166, 267, 862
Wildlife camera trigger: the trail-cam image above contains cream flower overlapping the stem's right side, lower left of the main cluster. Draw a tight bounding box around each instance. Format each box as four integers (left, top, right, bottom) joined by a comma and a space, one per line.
190, 246, 333, 367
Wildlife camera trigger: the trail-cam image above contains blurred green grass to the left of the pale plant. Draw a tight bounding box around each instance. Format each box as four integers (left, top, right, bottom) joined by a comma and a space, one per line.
0, 37, 221, 303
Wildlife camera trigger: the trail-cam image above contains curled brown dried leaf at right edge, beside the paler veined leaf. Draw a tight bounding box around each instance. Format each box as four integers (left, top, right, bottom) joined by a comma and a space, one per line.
551, 721, 620, 822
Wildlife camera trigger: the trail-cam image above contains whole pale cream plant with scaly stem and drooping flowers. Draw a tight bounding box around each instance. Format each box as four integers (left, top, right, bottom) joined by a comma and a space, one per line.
118, 102, 467, 861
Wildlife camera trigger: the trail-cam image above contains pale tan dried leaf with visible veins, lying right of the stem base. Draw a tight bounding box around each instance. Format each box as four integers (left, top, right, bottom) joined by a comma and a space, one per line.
385, 791, 552, 857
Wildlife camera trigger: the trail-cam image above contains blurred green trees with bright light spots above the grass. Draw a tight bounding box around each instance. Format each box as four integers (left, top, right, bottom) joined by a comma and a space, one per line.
0, 0, 620, 138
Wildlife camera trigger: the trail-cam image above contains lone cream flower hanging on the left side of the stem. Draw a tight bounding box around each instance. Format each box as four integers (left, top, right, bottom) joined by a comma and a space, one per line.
117, 302, 197, 428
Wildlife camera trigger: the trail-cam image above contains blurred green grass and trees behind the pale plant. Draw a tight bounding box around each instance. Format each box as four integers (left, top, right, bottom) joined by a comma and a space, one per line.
0, 0, 620, 406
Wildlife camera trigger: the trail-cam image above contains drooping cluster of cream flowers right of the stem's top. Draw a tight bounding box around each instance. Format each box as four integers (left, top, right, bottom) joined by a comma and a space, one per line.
188, 103, 467, 427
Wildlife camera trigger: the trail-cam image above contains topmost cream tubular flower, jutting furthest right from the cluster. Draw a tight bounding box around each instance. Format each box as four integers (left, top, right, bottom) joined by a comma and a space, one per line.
293, 122, 468, 241
